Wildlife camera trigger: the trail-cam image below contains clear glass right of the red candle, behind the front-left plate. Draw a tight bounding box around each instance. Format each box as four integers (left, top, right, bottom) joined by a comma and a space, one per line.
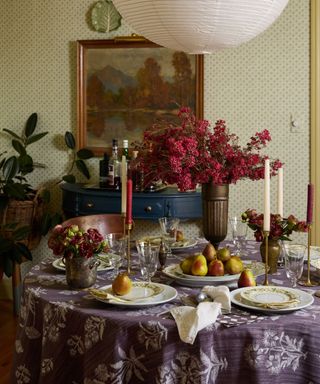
136, 240, 160, 282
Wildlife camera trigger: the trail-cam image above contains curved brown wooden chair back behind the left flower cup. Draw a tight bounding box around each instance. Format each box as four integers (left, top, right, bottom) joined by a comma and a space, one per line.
62, 213, 124, 235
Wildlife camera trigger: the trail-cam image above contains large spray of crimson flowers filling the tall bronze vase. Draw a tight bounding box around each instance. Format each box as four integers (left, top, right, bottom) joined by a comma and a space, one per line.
136, 107, 282, 191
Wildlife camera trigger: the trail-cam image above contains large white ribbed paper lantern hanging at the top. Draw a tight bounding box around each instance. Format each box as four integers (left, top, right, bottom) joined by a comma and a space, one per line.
113, 0, 288, 53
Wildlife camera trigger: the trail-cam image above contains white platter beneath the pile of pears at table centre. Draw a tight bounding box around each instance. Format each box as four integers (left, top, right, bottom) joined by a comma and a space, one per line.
163, 260, 265, 287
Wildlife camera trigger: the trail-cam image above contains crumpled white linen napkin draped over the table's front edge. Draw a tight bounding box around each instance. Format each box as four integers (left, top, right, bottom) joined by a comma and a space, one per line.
170, 286, 231, 344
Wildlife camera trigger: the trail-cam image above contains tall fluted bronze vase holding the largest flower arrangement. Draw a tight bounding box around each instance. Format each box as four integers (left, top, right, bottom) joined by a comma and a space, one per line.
202, 183, 229, 248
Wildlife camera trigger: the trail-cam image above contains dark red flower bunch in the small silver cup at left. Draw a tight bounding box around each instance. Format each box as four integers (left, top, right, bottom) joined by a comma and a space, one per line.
48, 225, 108, 258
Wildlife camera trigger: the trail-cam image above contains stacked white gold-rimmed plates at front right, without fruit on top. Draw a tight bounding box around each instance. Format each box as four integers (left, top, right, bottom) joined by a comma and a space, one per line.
230, 286, 314, 313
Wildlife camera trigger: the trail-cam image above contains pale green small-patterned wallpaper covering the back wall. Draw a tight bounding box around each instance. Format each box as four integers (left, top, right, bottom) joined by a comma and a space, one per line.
0, 0, 309, 272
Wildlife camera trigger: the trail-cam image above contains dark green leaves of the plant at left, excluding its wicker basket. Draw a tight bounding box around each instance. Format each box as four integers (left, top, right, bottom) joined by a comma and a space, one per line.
0, 113, 93, 276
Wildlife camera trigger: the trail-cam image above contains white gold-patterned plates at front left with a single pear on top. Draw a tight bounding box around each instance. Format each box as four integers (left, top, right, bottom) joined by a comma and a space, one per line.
89, 281, 178, 308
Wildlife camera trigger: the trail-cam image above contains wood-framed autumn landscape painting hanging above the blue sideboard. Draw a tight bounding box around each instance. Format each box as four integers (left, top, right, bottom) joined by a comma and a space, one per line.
77, 38, 203, 156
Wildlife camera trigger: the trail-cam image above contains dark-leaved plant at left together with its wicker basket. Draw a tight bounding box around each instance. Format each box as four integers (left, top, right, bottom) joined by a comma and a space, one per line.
0, 113, 93, 278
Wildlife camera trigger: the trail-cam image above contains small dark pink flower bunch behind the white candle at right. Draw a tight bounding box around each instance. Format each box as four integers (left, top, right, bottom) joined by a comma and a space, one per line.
242, 209, 308, 241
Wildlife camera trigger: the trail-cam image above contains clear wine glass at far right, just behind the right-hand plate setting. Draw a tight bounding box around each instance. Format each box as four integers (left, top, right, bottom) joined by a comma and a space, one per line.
284, 244, 307, 287
